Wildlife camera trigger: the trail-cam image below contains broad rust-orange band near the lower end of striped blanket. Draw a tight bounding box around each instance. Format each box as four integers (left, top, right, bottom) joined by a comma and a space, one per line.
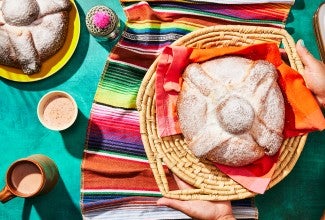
83, 153, 178, 192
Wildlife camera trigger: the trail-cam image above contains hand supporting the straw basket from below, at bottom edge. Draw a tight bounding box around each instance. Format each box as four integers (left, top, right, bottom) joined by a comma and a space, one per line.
157, 175, 235, 220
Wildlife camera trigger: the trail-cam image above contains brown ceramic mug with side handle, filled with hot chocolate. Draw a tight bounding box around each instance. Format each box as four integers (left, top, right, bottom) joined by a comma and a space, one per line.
0, 154, 59, 203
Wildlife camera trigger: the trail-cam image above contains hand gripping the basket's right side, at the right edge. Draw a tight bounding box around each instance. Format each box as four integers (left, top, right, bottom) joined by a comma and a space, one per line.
296, 40, 325, 107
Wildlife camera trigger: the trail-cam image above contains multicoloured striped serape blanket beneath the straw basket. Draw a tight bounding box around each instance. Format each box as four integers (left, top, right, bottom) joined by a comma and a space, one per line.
81, 0, 294, 219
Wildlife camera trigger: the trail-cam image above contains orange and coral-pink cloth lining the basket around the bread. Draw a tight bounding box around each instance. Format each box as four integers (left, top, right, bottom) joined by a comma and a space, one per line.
155, 43, 325, 193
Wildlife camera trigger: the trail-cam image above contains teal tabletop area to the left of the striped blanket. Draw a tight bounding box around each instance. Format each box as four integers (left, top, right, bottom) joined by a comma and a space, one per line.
0, 0, 125, 220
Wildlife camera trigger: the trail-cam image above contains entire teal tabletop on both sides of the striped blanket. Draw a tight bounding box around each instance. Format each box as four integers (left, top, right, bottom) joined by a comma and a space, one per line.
0, 0, 325, 220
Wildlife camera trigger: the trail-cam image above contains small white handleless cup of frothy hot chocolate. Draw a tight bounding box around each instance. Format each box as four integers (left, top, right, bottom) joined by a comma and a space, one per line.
37, 91, 78, 131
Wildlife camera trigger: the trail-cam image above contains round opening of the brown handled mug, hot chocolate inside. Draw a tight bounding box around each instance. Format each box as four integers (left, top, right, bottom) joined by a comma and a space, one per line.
11, 162, 42, 195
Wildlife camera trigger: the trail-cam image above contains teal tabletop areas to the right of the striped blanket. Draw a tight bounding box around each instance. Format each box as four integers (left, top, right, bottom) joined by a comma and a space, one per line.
256, 0, 325, 220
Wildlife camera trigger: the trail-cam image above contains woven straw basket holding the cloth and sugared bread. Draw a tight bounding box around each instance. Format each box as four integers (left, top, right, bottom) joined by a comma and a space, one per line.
137, 25, 307, 200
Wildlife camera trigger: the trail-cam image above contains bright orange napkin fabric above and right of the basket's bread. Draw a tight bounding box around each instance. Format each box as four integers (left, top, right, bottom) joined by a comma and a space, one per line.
189, 43, 325, 137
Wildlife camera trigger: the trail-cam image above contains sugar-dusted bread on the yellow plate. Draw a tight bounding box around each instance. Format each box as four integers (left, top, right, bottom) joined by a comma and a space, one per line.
0, 0, 71, 74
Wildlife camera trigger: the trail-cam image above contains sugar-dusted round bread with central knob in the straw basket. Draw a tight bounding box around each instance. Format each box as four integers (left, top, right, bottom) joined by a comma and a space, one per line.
177, 57, 284, 166
